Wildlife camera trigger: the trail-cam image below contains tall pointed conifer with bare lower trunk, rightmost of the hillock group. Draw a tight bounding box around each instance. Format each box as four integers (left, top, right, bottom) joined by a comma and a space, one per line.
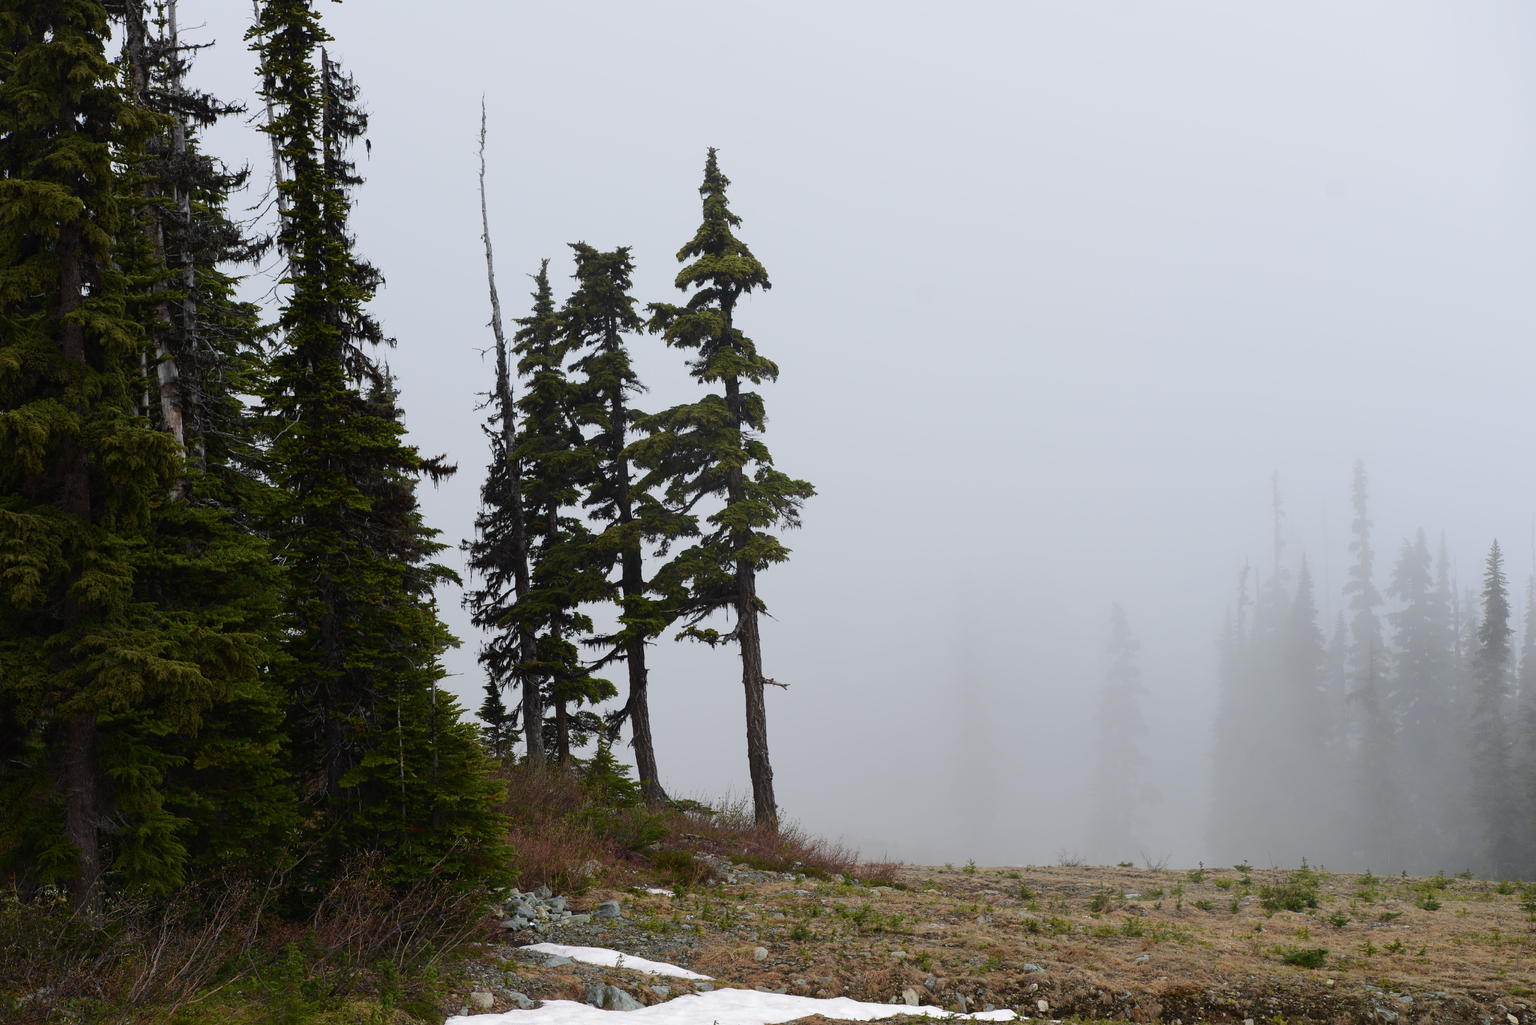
633, 148, 816, 827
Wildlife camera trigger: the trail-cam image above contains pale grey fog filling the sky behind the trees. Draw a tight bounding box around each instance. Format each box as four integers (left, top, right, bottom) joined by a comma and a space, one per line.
181, 0, 1536, 871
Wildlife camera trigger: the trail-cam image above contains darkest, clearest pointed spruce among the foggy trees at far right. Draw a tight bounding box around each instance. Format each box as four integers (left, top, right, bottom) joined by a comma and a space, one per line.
1470, 541, 1519, 876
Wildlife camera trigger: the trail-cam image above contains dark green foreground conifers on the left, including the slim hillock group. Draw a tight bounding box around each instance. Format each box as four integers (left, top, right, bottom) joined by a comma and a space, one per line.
0, 0, 811, 916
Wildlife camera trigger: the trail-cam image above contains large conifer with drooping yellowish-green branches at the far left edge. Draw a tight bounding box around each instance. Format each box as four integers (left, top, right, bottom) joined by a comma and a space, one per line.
0, 0, 283, 914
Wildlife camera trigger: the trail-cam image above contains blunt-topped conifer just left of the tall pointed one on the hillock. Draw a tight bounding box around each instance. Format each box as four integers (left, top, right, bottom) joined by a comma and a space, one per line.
561, 243, 685, 804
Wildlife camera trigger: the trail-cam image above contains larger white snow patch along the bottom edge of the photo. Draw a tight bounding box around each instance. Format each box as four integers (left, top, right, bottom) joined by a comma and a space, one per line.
447, 989, 1017, 1025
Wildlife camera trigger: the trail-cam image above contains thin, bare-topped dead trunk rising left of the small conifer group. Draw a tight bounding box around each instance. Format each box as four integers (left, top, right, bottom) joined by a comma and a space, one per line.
479, 108, 548, 767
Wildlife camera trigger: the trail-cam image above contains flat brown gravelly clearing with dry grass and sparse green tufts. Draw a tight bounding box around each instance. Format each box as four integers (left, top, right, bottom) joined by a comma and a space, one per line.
444, 861, 1536, 1025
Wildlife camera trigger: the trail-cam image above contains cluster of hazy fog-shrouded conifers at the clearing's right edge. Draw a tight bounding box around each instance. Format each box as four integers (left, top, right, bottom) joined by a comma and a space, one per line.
1209, 464, 1536, 877
